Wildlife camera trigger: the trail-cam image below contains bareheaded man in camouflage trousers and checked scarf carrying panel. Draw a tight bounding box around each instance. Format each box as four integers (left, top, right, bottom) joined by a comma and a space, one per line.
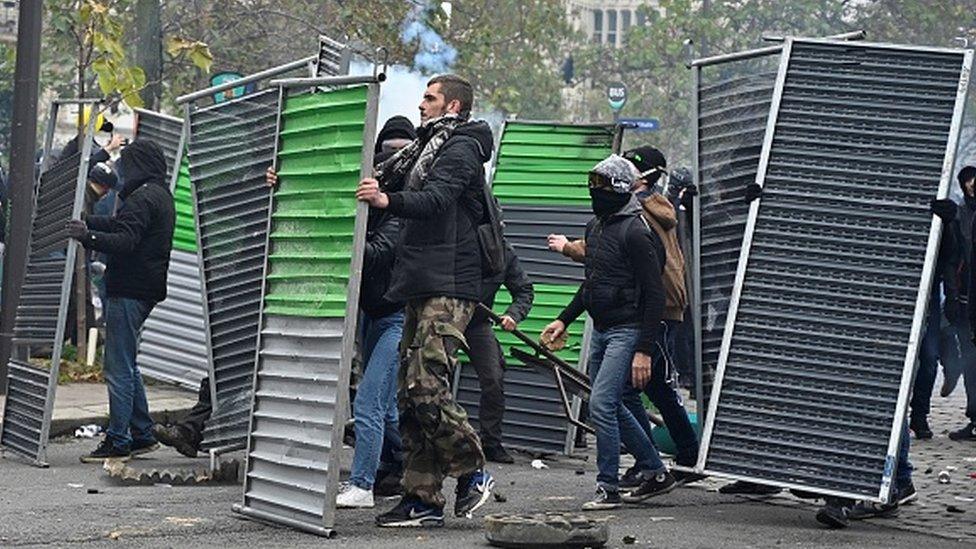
356, 75, 494, 527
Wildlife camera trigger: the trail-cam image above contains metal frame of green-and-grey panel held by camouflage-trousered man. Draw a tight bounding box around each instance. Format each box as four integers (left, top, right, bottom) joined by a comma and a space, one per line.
233, 77, 384, 537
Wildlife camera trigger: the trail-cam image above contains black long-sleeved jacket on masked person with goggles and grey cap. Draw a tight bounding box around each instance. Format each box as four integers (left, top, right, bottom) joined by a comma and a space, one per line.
559, 199, 667, 354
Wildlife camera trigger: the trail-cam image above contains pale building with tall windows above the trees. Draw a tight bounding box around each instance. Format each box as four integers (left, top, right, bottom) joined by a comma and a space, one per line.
566, 0, 657, 47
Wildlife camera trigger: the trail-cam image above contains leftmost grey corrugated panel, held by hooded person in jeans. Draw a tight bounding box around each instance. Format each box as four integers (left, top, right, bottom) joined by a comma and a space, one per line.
0, 119, 94, 466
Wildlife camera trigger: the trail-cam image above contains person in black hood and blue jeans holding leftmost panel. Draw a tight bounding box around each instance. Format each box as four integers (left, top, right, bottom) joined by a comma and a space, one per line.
66, 139, 176, 463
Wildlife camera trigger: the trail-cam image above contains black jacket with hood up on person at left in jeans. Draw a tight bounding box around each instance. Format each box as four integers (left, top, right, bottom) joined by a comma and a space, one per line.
82, 139, 176, 302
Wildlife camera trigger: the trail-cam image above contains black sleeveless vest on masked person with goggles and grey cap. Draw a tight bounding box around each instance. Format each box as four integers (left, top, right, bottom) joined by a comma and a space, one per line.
583, 206, 665, 331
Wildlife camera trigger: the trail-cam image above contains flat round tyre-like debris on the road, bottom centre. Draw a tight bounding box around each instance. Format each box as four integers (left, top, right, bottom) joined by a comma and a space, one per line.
485, 513, 610, 548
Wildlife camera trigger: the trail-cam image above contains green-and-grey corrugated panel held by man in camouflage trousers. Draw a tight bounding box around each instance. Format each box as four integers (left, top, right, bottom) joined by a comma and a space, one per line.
235, 84, 379, 535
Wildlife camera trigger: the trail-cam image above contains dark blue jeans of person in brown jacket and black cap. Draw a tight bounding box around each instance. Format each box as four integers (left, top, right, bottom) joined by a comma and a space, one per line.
624, 320, 698, 467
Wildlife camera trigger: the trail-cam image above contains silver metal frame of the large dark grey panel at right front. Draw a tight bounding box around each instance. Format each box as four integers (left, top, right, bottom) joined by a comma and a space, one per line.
696, 38, 973, 503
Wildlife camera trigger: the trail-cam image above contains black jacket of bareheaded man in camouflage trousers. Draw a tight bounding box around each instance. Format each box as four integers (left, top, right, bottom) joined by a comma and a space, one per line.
387, 121, 494, 302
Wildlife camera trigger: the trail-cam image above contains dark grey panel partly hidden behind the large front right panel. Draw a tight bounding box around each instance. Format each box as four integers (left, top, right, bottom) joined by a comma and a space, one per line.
688, 50, 781, 423
